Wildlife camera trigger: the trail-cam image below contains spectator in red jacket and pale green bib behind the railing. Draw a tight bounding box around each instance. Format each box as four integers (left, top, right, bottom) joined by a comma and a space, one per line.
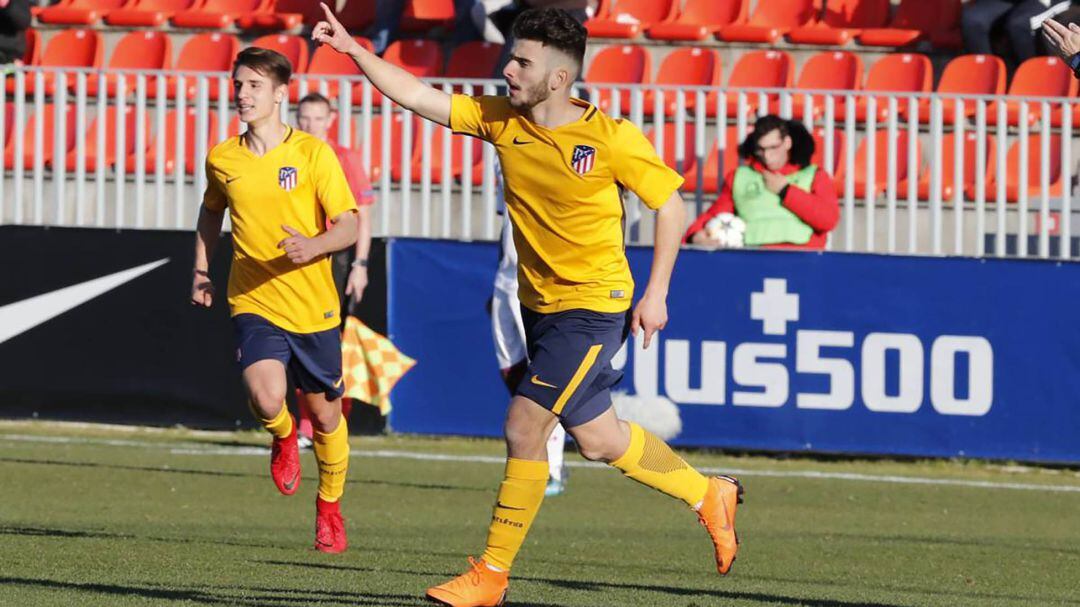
684, 114, 840, 248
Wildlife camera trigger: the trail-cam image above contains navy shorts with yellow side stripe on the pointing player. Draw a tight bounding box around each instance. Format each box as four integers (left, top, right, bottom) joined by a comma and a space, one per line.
516, 307, 630, 428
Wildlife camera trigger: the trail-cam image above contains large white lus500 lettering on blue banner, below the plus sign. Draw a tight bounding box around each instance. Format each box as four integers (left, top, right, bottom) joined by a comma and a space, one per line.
612, 331, 994, 416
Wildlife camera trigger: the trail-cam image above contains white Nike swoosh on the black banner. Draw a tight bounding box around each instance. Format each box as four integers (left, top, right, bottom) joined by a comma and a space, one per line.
0, 257, 168, 343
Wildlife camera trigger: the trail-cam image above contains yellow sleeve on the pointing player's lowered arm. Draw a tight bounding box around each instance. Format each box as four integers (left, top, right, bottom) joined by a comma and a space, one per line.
610, 120, 683, 208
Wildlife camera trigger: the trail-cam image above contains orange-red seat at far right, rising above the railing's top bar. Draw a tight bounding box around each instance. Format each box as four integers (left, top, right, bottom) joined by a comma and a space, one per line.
986, 57, 1077, 126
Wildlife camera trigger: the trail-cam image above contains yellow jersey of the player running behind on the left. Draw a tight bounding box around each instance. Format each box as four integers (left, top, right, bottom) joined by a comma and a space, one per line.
203, 129, 356, 333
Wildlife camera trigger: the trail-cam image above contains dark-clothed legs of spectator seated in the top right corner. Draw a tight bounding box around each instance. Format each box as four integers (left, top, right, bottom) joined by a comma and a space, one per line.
960, 0, 1069, 63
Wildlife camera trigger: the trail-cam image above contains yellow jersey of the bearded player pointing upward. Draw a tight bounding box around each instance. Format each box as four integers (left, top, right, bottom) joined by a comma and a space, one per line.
450, 95, 683, 313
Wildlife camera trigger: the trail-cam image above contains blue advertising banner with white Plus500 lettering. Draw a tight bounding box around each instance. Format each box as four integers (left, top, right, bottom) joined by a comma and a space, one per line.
389, 240, 1080, 462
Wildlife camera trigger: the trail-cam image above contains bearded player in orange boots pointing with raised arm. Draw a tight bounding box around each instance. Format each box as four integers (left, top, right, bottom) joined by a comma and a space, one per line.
312, 4, 741, 607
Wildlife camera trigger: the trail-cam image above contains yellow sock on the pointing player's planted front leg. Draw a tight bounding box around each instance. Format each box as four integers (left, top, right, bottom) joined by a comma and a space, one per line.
484, 458, 548, 571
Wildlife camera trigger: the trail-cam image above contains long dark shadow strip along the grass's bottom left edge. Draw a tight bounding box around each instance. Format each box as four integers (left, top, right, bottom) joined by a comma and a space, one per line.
0, 576, 424, 607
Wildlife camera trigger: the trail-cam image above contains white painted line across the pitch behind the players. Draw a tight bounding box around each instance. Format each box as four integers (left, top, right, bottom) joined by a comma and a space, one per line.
6, 434, 1080, 494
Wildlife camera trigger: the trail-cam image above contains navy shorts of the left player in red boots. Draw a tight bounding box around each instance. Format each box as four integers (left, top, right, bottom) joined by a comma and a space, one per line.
232, 314, 345, 401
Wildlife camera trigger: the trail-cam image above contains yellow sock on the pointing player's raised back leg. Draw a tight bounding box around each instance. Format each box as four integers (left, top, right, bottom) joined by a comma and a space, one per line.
611, 422, 708, 508
